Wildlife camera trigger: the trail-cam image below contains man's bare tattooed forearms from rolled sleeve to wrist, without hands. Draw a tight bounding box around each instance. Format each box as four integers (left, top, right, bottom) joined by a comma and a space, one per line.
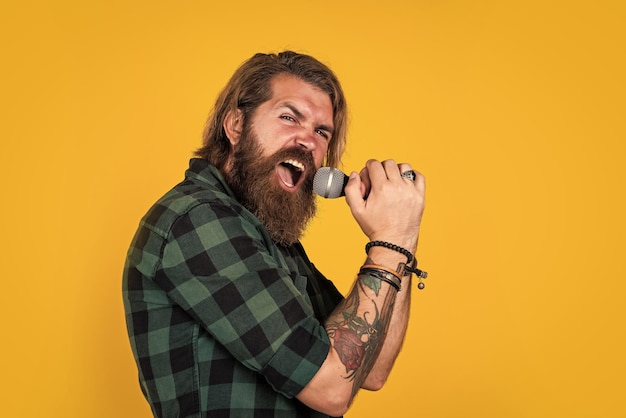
298, 249, 410, 414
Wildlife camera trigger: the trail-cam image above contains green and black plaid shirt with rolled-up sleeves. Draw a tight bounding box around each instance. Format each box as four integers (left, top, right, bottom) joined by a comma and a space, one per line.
123, 159, 342, 417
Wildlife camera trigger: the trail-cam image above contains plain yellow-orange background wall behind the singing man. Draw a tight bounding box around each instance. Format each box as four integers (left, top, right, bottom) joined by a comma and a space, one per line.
0, 0, 626, 418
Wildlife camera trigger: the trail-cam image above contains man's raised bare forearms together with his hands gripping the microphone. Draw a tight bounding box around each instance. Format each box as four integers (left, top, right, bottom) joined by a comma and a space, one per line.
297, 160, 424, 415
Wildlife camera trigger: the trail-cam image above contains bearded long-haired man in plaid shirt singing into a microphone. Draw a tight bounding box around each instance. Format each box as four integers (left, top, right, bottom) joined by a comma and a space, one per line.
123, 51, 424, 417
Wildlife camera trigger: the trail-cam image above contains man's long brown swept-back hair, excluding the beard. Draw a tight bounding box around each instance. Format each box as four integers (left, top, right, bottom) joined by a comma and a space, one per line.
195, 51, 347, 170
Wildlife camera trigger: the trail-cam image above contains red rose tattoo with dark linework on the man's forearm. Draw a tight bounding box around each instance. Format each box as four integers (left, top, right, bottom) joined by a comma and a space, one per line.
327, 266, 395, 396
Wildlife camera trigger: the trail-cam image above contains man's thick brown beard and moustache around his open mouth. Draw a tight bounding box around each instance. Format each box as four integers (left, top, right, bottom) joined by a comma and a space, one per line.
224, 127, 317, 246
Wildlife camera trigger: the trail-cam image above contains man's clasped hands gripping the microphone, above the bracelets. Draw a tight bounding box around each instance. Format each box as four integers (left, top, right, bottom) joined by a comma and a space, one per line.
345, 160, 425, 252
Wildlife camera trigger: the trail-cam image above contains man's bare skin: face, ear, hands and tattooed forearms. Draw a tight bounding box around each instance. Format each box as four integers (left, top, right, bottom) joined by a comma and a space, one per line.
224, 75, 425, 416
